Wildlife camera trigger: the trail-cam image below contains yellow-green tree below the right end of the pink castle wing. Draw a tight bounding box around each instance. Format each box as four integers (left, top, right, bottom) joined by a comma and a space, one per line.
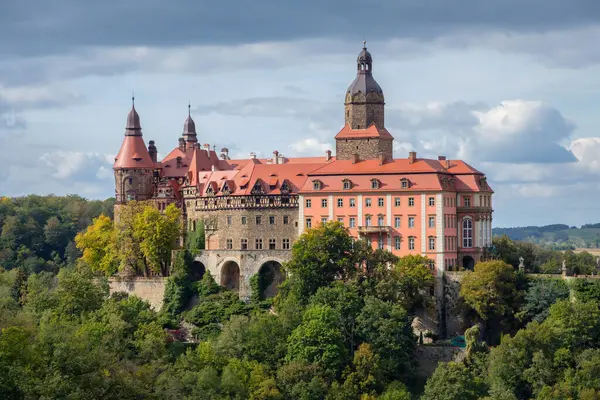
460, 261, 522, 343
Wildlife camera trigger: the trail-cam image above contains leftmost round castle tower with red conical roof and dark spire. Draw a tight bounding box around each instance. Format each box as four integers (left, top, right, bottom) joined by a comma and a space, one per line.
113, 98, 156, 204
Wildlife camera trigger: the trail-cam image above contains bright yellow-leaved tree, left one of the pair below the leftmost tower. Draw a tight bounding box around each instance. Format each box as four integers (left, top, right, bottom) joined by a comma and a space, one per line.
75, 214, 119, 276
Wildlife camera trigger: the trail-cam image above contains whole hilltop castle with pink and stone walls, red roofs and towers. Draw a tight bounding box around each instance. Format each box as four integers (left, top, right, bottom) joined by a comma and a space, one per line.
113, 45, 493, 297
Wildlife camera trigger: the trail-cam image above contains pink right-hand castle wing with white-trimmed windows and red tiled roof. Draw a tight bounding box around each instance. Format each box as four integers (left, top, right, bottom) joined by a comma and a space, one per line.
299, 153, 493, 273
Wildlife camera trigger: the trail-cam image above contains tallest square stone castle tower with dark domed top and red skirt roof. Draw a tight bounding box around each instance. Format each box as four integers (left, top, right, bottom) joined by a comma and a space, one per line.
335, 42, 394, 160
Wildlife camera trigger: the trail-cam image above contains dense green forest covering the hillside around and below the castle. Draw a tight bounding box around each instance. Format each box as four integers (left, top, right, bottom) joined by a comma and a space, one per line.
0, 194, 600, 400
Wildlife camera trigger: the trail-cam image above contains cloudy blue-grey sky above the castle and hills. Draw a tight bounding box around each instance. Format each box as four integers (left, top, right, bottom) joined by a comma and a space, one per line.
0, 0, 600, 227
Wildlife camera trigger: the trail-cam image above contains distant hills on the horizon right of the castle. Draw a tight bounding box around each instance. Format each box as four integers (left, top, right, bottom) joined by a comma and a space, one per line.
493, 223, 600, 249
